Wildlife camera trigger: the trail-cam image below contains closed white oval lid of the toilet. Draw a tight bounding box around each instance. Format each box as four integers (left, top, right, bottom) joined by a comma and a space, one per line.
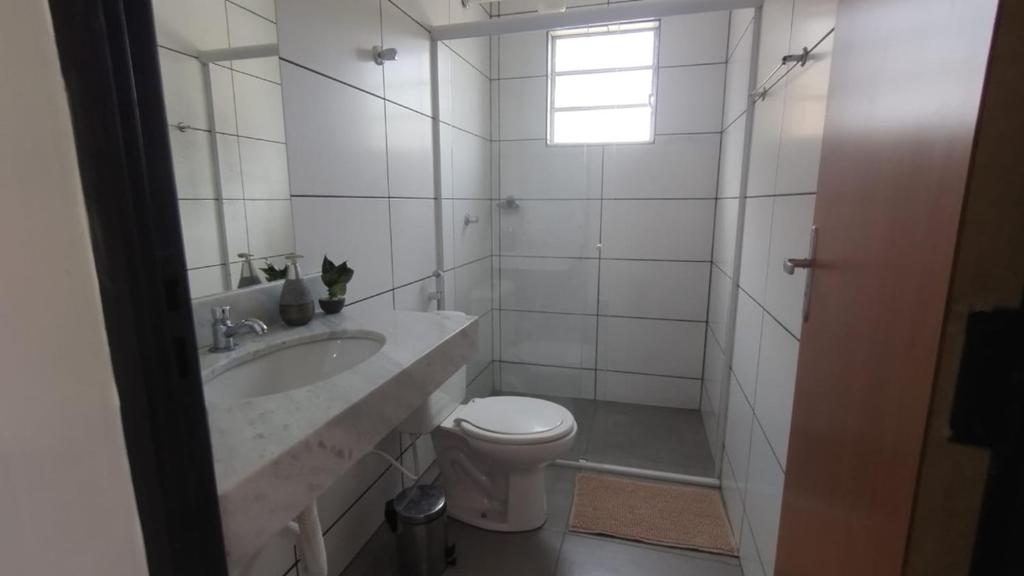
454, 396, 575, 445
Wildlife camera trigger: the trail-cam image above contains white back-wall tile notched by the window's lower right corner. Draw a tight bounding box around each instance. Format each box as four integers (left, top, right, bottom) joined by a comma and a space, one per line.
602, 134, 721, 198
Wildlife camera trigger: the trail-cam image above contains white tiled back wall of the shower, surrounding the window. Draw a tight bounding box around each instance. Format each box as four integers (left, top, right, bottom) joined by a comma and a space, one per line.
493, 12, 730, 409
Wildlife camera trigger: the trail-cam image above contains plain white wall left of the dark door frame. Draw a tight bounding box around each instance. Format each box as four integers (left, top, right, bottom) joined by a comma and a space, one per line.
0, 0, 147, 576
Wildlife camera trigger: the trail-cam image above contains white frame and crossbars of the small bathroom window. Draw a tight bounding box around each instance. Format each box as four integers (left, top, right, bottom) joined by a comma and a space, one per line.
546, 19, 662, 146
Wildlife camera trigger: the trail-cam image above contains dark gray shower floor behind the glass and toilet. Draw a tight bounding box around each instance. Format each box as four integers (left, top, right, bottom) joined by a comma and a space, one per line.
505, 397, 715, 477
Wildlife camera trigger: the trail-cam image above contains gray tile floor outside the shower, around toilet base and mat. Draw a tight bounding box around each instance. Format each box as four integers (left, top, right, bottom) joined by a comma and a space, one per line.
342, 466, 742, 576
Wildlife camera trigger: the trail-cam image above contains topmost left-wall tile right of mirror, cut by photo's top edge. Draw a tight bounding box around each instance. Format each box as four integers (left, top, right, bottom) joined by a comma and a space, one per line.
278, 0, 384, 95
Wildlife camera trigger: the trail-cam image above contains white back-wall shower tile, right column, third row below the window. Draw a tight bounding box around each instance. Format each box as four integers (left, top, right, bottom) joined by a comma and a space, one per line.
600, 259, 711, 321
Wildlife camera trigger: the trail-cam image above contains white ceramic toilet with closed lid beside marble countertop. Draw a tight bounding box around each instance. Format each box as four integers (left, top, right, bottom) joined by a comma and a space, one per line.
398, 368, 577, 532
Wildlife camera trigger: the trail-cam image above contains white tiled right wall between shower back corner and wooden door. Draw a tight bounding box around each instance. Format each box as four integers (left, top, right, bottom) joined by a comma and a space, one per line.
705, 0, 835, 576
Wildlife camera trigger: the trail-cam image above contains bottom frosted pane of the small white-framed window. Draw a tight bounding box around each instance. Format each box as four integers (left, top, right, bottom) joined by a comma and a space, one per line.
552, 107, 651, 143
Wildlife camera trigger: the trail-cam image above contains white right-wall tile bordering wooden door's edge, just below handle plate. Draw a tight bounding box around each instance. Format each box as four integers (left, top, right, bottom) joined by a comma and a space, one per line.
755, 317, 800, 468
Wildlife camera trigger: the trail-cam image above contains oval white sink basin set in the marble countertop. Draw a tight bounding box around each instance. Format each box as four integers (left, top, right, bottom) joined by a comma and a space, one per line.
204, 335, 384, 404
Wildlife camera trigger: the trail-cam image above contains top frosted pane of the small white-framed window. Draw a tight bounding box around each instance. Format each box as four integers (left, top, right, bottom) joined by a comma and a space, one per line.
554, 30, 654, 72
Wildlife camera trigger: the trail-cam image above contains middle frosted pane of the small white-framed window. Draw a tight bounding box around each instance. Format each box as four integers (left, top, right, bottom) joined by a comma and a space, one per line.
555, 70, 653, 108
